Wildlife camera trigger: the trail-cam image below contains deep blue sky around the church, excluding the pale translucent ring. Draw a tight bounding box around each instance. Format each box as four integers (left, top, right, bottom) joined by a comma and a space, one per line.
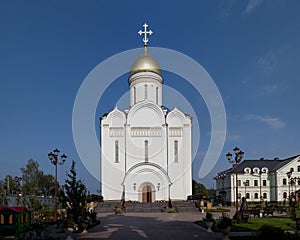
0, 0, 300, 192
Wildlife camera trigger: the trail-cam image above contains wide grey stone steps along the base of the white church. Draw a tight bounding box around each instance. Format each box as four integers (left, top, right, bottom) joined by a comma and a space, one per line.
95, 201, 199, 213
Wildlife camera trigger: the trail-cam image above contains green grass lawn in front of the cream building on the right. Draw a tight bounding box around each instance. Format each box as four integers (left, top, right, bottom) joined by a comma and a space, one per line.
195, 216, 295, 232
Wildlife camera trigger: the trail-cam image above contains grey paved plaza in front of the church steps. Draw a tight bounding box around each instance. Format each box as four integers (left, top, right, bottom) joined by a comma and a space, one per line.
51, 213, 222, 240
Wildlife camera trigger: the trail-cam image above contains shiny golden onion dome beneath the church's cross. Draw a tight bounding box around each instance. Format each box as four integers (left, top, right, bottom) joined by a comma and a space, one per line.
130, 47, 162, 76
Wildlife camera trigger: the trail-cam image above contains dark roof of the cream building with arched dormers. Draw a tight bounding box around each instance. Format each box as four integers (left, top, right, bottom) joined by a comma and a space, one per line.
217, 155, 300, 176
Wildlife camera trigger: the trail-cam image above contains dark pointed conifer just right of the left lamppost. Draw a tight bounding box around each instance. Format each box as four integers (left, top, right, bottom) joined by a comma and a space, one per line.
59, 160, 87, 224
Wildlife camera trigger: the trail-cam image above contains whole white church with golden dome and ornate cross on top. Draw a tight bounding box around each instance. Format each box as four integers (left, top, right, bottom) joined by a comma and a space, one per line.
101, 23, 192, 202
